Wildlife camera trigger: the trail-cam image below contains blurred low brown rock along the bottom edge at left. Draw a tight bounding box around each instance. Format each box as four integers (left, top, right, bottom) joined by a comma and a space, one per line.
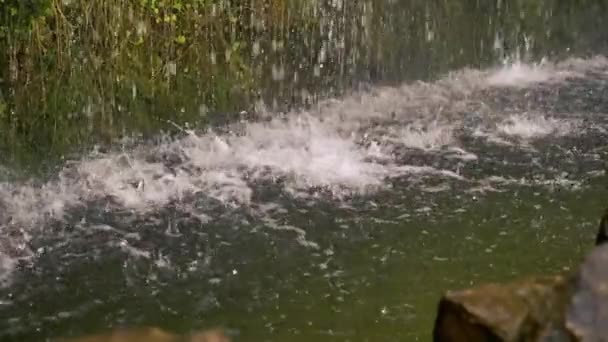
57, 328, 230, 342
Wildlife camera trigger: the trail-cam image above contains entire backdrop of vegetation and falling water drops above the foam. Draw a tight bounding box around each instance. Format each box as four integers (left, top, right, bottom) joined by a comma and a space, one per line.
0, 0, 605, 170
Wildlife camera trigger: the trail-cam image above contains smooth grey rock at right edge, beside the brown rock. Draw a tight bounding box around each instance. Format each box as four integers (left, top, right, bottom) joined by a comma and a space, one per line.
566, 244, 608, 342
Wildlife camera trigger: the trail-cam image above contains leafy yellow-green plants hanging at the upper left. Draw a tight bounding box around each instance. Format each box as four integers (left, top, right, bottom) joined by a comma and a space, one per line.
0, 0, 314, 168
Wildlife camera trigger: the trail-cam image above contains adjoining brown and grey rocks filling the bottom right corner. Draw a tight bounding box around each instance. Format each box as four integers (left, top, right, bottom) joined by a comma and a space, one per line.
433, 210, 608, 342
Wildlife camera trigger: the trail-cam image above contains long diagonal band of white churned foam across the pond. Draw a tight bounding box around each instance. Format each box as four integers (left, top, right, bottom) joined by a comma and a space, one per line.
0, 57, 608, 286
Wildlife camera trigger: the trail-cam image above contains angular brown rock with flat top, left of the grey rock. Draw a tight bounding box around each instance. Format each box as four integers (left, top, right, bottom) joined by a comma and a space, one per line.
433, 276, 571, 342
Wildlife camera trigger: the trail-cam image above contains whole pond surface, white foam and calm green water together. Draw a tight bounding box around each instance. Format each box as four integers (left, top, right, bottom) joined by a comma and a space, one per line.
0, 1, 608, 341
